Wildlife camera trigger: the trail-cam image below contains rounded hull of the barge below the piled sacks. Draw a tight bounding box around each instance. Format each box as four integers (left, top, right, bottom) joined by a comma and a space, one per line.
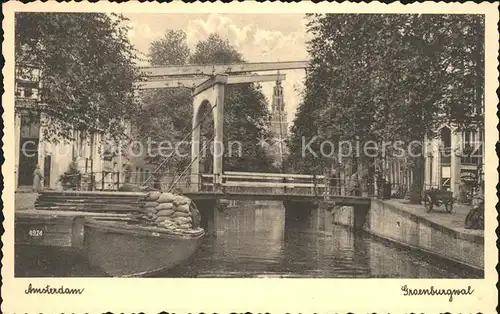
84, 222, 204, 277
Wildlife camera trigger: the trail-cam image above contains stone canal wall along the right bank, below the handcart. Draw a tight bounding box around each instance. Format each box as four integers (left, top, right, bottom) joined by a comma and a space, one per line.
332, 199, 484, 270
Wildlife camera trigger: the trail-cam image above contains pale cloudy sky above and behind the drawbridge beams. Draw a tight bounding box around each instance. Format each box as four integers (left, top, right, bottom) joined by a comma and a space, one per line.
125, 14, 309, 125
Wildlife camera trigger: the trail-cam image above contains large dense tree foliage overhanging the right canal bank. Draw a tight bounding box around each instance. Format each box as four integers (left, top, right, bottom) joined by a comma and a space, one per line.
290, 14, 484, 188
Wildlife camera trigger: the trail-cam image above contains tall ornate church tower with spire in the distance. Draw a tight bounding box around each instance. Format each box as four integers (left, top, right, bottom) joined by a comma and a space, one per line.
270, 77, 288, 162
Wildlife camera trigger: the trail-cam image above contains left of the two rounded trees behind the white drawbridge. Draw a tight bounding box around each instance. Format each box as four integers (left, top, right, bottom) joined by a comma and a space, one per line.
134, 30, 193, 177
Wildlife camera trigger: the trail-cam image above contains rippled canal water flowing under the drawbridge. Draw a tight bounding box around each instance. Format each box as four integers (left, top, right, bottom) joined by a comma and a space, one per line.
16, 203, 474, 278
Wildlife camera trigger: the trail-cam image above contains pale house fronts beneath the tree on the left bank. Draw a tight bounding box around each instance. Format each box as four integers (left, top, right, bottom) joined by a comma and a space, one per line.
14, 64, 127, 191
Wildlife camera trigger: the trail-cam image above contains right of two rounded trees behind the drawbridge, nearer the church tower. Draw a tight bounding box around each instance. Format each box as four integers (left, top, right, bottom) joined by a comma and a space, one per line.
190, 34, 278, 171
